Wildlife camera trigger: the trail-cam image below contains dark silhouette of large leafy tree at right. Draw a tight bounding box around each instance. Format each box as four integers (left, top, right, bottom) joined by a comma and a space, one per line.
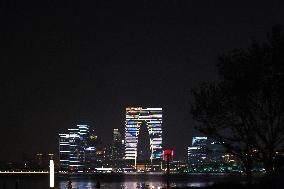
190, 25, 284, 174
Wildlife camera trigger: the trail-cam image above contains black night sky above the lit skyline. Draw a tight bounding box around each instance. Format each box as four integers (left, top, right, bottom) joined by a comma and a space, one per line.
0, 0, 284, 160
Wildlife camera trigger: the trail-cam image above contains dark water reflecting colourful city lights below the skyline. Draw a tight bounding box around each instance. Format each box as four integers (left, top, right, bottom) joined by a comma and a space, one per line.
0, 174, 247, 189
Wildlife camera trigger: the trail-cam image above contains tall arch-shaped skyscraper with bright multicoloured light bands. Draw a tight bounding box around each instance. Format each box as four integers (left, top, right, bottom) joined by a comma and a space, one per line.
125, 107, 162, 167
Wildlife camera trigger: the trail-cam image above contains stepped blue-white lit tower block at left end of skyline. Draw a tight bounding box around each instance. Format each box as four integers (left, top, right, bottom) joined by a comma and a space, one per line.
59, 125, 95, 171
